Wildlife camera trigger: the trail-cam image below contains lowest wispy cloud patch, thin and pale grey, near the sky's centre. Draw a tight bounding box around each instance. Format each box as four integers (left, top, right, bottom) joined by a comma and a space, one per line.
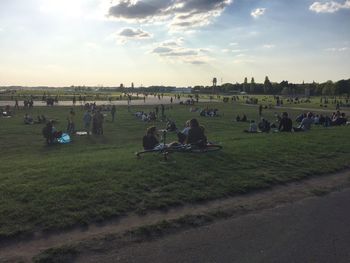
151, 39, 211, 65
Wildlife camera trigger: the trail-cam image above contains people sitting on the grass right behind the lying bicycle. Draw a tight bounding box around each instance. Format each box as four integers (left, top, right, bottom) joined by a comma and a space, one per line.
142, 119, 207, 150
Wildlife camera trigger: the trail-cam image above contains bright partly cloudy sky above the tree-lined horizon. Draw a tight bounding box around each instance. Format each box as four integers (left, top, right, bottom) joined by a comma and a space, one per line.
0, 0, 350, 87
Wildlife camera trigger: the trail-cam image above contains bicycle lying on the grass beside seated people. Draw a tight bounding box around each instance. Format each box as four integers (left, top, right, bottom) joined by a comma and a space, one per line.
136, 130, 223, 161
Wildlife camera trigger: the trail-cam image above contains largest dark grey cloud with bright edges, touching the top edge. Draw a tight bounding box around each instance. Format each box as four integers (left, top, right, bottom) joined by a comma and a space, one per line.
108, 0, 233, 30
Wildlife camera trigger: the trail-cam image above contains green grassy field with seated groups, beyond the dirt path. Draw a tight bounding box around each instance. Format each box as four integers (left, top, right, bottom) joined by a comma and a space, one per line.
0, 103, 350, 239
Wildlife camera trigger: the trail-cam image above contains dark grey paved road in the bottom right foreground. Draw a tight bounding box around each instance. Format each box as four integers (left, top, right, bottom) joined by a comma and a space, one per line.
80, 189, 350, 263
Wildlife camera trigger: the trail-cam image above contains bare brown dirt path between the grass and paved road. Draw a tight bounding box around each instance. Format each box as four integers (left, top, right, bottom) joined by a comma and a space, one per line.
0, 170, 350, 262
